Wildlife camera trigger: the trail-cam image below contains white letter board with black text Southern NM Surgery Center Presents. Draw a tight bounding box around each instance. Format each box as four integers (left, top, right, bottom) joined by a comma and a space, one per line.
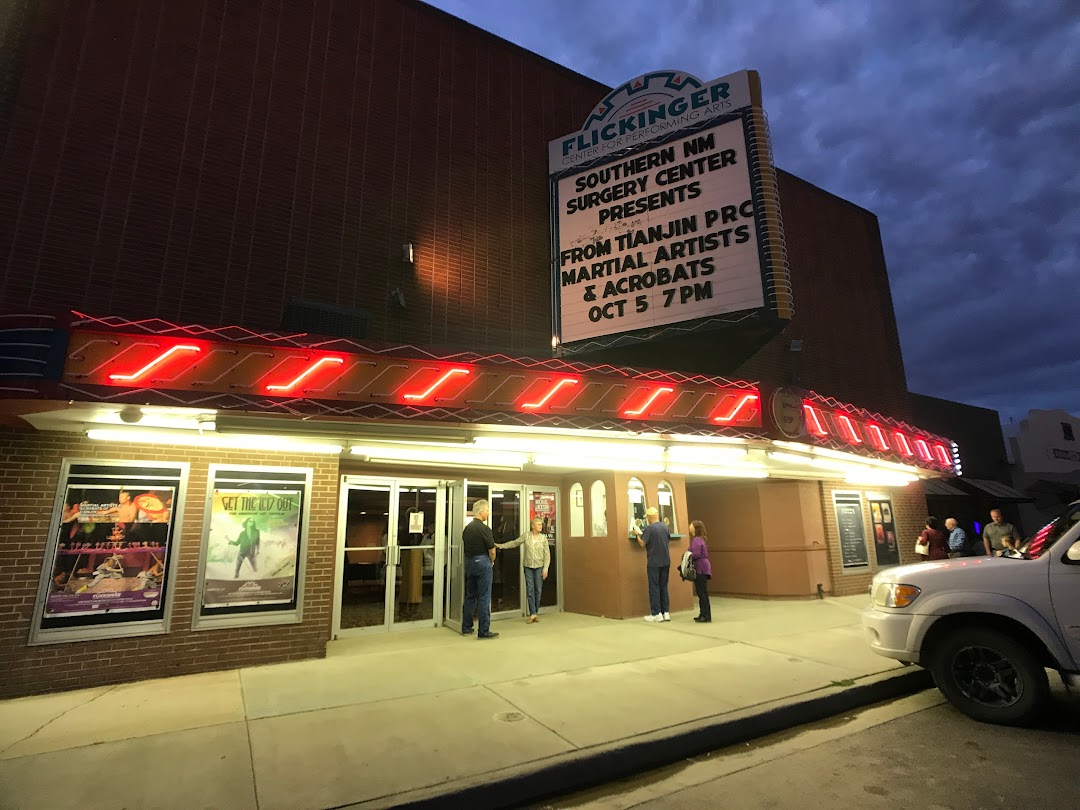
555, 119, 765, 342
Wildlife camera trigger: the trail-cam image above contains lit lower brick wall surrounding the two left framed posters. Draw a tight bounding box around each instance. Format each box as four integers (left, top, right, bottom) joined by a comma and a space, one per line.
0, 429, 338, 698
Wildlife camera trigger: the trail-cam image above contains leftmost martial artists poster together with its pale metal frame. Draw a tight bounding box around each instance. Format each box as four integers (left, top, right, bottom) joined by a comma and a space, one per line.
29, 459, 189, 644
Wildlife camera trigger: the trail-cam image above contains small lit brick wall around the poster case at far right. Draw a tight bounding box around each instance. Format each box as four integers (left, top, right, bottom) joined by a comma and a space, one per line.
821, 483, 927, 596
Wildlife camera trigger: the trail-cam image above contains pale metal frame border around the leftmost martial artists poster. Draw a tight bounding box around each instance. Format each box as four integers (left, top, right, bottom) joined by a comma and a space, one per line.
26, 457, 191, 647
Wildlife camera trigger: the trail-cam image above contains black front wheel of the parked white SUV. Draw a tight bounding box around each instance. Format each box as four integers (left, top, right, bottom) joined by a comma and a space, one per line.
930, 627, 1050, 726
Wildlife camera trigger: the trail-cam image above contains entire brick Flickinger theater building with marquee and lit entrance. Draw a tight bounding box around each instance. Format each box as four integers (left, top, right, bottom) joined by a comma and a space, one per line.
0, 0, 957, 697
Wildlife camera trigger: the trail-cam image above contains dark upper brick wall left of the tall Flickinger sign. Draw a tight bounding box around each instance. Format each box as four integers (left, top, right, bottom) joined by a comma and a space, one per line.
0, 0, 606, 353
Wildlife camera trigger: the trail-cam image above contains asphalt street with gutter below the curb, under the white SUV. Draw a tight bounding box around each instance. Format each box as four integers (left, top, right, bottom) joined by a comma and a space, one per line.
538, 674, 1080, 810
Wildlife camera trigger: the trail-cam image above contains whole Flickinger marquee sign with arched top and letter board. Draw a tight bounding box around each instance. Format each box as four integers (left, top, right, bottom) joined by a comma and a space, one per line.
549, 70, 791, 353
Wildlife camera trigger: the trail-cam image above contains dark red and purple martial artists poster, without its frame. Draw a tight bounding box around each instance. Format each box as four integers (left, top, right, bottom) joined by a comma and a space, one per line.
43, 475, 176, 619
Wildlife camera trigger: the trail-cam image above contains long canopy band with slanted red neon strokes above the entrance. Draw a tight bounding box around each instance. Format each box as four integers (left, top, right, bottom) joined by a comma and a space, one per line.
52, 319, 953, 471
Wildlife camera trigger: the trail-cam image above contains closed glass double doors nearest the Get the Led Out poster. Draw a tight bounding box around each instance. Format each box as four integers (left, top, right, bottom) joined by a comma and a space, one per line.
334, 476, 442, 637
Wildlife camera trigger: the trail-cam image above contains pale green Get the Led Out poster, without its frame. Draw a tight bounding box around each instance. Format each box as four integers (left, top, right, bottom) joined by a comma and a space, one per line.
202, 489, 302, 608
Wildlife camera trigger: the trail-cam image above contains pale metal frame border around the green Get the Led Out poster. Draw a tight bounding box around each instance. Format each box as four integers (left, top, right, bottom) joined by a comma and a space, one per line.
191, 462, 314, 631
